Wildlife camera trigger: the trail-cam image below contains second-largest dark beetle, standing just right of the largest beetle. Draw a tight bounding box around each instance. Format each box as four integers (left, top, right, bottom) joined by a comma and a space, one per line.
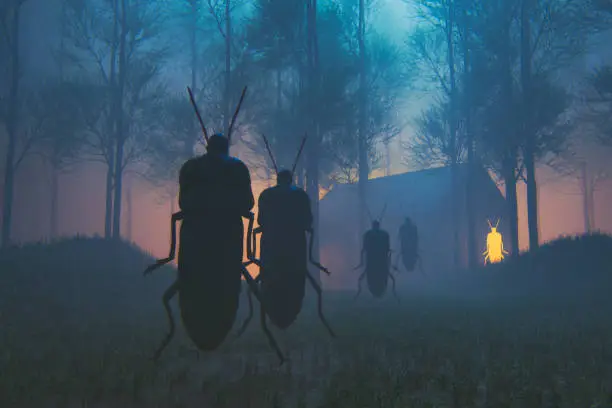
237, 135, 335, 344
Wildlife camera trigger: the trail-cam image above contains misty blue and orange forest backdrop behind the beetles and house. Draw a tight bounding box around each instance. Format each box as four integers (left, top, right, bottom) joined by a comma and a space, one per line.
0, 0, 612, 270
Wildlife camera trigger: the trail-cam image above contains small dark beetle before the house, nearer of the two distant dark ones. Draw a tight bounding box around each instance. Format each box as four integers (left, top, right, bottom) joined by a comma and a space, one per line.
354, 204, 399, 302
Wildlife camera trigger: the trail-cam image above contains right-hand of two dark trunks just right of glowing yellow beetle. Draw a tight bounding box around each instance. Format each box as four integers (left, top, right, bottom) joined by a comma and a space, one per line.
521, 0, 540, 250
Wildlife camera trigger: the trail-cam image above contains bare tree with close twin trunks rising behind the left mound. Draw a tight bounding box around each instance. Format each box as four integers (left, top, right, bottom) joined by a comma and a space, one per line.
61, 0, 166, 238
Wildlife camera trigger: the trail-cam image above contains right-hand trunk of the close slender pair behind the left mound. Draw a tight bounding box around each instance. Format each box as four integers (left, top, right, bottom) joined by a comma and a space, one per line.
113, 0, 128, 240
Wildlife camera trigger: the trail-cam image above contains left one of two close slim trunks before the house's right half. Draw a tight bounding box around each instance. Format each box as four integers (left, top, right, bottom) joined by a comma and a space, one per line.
446, 0, 461, 268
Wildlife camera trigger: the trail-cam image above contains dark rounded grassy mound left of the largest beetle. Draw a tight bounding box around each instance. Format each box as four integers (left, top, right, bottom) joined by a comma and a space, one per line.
0, 237, 176, 324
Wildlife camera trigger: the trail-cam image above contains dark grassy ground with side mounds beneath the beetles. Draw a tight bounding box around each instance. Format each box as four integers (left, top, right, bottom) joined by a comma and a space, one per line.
0, 234, 612, 408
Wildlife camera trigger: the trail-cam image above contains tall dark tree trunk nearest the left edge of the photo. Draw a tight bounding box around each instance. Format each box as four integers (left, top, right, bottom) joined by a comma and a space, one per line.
2, 4, 21, 247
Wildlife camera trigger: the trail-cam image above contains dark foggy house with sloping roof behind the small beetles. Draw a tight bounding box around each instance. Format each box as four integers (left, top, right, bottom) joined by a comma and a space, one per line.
319, 165, 513, 288
